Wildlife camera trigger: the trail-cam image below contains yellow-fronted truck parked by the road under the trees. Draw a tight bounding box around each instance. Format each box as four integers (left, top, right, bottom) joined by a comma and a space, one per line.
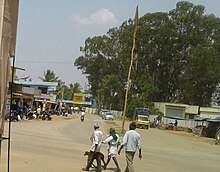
133, 108, 150, 129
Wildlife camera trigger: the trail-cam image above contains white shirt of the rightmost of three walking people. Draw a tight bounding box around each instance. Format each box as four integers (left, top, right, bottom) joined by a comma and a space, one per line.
121, 130, 141, 152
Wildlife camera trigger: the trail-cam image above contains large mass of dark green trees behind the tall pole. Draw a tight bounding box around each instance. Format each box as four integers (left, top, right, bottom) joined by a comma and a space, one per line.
74, 1, 220, 117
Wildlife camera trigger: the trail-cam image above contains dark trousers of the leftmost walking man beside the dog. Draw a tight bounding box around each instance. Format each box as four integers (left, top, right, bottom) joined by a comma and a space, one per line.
86, 151, 102, 172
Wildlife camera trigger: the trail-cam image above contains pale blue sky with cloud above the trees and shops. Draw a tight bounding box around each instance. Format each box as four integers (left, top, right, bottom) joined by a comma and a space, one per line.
15, 0, 220, 89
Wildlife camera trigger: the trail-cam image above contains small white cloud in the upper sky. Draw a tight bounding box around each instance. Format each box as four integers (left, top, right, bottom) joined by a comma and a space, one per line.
70, 8, 118, 25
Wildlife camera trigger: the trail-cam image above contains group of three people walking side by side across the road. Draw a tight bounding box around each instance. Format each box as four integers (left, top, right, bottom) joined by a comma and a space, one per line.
82, 122, 142, 172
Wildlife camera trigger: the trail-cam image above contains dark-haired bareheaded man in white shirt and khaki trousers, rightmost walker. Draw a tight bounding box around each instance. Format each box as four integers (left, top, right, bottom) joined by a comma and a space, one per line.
118, 122, 142, 172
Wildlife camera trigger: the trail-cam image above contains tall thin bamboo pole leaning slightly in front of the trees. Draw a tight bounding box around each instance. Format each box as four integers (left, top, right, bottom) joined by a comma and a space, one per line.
122, 6, 138, 133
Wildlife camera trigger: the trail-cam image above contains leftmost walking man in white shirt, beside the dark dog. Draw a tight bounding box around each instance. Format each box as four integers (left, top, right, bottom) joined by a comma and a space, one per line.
82, 123, 103, 172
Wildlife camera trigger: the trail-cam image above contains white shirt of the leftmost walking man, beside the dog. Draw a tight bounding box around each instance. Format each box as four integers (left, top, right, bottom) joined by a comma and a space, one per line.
91, 129, 103, 152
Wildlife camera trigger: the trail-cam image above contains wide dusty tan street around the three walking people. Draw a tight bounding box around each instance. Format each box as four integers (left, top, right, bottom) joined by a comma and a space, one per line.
0, 114, 220, 172
